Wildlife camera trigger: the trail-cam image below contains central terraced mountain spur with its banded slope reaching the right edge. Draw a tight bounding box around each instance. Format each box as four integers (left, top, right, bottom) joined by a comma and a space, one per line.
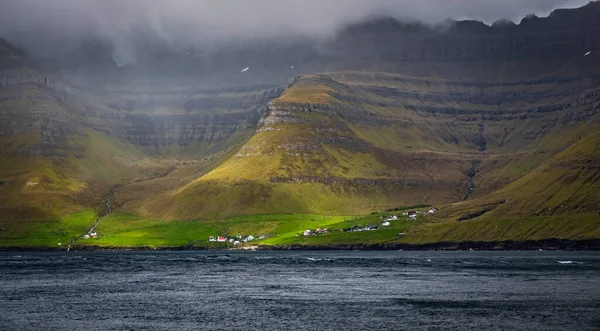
123, 68, 600, 219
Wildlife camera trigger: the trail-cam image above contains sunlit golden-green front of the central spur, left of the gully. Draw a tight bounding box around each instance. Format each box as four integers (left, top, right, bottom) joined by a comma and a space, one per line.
123, 76, 471, 219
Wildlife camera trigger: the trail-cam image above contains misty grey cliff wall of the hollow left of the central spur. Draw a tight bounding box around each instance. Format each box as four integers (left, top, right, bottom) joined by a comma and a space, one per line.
96, 86, 283, 156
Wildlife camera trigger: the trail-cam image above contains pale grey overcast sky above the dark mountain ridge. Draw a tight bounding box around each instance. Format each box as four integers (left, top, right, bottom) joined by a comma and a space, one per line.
0, 0, 589, 37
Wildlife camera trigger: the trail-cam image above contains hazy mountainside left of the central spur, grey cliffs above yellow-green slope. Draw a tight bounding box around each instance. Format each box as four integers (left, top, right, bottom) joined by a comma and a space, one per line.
0, 39, 278, 220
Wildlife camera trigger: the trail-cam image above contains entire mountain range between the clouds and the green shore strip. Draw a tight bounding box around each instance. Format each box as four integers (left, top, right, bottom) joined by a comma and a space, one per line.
0, 2, 600, 246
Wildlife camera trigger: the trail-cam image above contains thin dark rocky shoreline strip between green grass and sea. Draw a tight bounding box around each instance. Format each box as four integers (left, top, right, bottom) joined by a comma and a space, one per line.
0, 239, 600, 252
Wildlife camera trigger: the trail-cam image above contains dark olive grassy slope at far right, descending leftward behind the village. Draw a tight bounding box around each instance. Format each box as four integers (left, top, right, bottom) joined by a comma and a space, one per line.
442, 127, 600, 221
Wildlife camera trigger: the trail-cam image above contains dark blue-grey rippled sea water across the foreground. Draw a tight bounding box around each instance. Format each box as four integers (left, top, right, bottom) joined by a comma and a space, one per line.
0, 251, 600, 331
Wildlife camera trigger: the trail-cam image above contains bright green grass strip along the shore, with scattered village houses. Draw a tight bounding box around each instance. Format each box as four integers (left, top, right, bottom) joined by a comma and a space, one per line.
0, 210, 600, 249
